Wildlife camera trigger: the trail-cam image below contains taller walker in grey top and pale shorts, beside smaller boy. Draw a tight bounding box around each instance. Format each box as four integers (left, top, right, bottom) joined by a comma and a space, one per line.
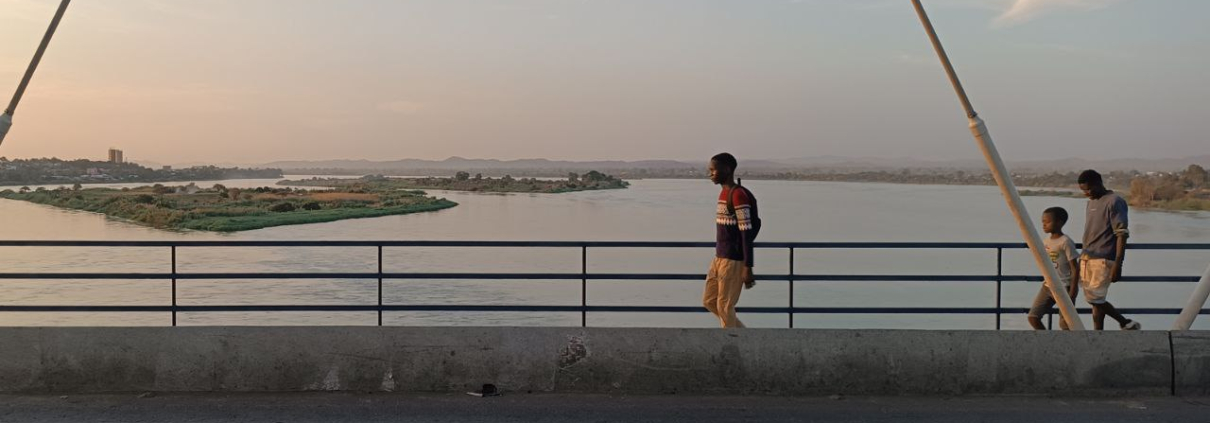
1077, 169, 1142, 330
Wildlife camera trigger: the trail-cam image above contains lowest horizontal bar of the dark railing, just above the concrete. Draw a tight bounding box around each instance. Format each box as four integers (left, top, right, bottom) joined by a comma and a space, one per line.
0, 305, 1210, 314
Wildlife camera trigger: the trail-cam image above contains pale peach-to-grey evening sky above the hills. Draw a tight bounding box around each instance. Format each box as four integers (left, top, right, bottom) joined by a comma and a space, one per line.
0, 0, 1210, 163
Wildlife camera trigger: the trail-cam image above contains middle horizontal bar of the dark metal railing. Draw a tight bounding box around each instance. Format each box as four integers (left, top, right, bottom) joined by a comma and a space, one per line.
0, 272, 1200, 283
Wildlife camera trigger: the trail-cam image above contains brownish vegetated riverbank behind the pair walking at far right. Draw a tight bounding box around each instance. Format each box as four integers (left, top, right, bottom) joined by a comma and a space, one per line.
1021, 164, 1210, 212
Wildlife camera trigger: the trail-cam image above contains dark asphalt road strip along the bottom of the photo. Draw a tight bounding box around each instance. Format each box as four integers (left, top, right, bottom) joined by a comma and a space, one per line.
0, 393, 1210, 423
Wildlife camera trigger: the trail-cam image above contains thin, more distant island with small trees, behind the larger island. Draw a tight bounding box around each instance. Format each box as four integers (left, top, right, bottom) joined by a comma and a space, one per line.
277, 170, 630, 193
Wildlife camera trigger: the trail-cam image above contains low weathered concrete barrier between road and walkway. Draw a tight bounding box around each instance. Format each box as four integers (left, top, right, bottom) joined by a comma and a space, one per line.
0, 326, 1195, 395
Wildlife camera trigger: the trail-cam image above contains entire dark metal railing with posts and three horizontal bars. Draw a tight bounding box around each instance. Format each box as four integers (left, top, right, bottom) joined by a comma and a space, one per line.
0, 241, 1210, 330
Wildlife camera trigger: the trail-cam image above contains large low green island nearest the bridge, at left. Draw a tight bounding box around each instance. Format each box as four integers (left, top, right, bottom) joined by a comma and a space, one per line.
0, 184, 457, 232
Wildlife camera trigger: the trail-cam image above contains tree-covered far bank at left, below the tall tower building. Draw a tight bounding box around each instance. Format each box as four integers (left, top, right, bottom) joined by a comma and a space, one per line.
0, 157, 282, 185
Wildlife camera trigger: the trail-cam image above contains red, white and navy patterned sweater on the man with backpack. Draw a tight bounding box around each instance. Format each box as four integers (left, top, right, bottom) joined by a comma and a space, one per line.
714, 186, 760, 267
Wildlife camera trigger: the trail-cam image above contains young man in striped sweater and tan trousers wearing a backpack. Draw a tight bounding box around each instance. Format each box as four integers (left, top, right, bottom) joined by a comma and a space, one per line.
702, 152, 760, 328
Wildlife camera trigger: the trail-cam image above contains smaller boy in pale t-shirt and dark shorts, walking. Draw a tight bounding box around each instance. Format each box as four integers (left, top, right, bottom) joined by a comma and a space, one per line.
1030, 207, 1079, 330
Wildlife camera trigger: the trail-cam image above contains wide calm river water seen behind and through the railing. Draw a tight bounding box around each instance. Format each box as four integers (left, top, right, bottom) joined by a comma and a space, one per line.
0, 176, 1210, 329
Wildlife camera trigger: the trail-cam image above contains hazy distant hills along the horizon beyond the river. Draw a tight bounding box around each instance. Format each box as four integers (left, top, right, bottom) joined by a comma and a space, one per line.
255, 155, 1210, 175
